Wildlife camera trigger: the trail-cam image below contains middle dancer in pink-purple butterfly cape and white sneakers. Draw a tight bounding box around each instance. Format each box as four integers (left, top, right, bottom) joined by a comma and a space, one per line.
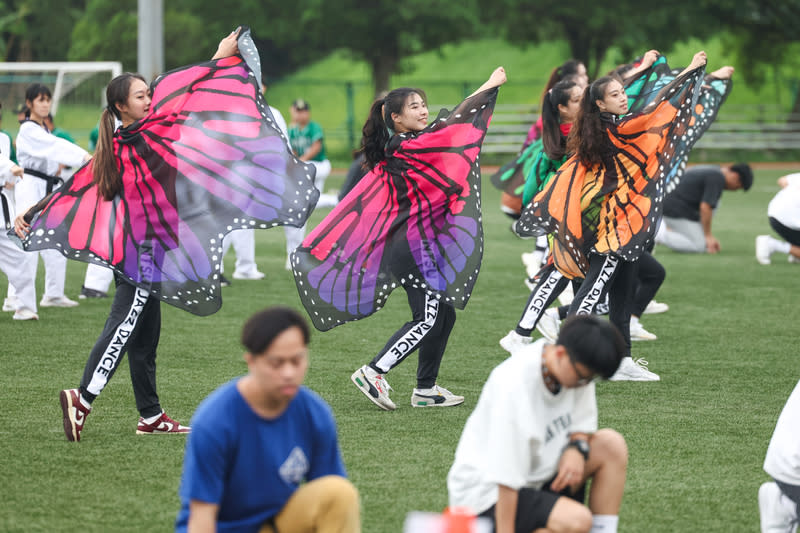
292, 68, 506, 410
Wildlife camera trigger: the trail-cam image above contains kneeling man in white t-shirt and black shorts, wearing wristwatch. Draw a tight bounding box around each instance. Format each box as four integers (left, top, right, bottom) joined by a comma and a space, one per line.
447, 316, 628, 533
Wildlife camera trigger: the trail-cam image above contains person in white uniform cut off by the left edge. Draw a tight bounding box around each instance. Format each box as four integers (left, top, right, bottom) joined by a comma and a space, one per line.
0, 154, 39, 320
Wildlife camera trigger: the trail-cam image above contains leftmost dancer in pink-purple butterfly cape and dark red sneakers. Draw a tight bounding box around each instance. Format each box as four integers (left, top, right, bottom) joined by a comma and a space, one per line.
15, 27, 318, 441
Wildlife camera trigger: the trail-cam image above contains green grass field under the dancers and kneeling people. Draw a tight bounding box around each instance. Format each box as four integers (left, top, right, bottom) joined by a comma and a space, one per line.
0, 165, 800, 533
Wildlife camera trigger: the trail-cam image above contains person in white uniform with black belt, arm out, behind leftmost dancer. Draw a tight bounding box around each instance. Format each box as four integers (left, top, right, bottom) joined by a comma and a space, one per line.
14, 83, 91, 307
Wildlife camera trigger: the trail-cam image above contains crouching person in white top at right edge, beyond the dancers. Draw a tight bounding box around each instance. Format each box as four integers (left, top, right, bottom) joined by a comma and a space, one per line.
756, 173, 800, 265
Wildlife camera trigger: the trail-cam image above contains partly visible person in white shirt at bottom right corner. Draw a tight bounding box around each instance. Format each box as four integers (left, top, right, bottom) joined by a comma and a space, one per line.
758, 381, 800, 533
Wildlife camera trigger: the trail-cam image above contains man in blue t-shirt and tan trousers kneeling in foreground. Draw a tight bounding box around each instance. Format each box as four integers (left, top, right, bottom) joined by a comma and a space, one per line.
175, 307, 361, 533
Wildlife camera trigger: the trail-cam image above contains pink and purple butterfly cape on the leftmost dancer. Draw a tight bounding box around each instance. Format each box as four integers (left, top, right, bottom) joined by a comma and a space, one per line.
23, 30, 319, 315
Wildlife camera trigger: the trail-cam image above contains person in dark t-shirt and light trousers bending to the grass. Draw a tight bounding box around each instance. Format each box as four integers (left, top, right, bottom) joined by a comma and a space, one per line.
656, 163, 753, 254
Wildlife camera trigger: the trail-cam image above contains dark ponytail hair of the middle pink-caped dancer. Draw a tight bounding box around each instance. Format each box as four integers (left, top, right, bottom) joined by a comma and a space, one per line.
361, 87, 428, 169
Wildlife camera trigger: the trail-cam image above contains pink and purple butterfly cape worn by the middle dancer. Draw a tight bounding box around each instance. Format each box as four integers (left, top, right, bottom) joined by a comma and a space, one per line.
292, 89, 497, 331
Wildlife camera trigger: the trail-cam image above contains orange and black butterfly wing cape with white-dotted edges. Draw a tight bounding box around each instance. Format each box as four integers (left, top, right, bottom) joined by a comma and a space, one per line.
517, 68, 704, 278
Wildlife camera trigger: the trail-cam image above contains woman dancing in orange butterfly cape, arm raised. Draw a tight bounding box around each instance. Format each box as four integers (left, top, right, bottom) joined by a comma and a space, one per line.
518, 52, 706, 381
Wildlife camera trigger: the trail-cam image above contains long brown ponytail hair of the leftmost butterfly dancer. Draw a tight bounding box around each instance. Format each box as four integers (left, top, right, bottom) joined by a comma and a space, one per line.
92, 72, 147, 200
